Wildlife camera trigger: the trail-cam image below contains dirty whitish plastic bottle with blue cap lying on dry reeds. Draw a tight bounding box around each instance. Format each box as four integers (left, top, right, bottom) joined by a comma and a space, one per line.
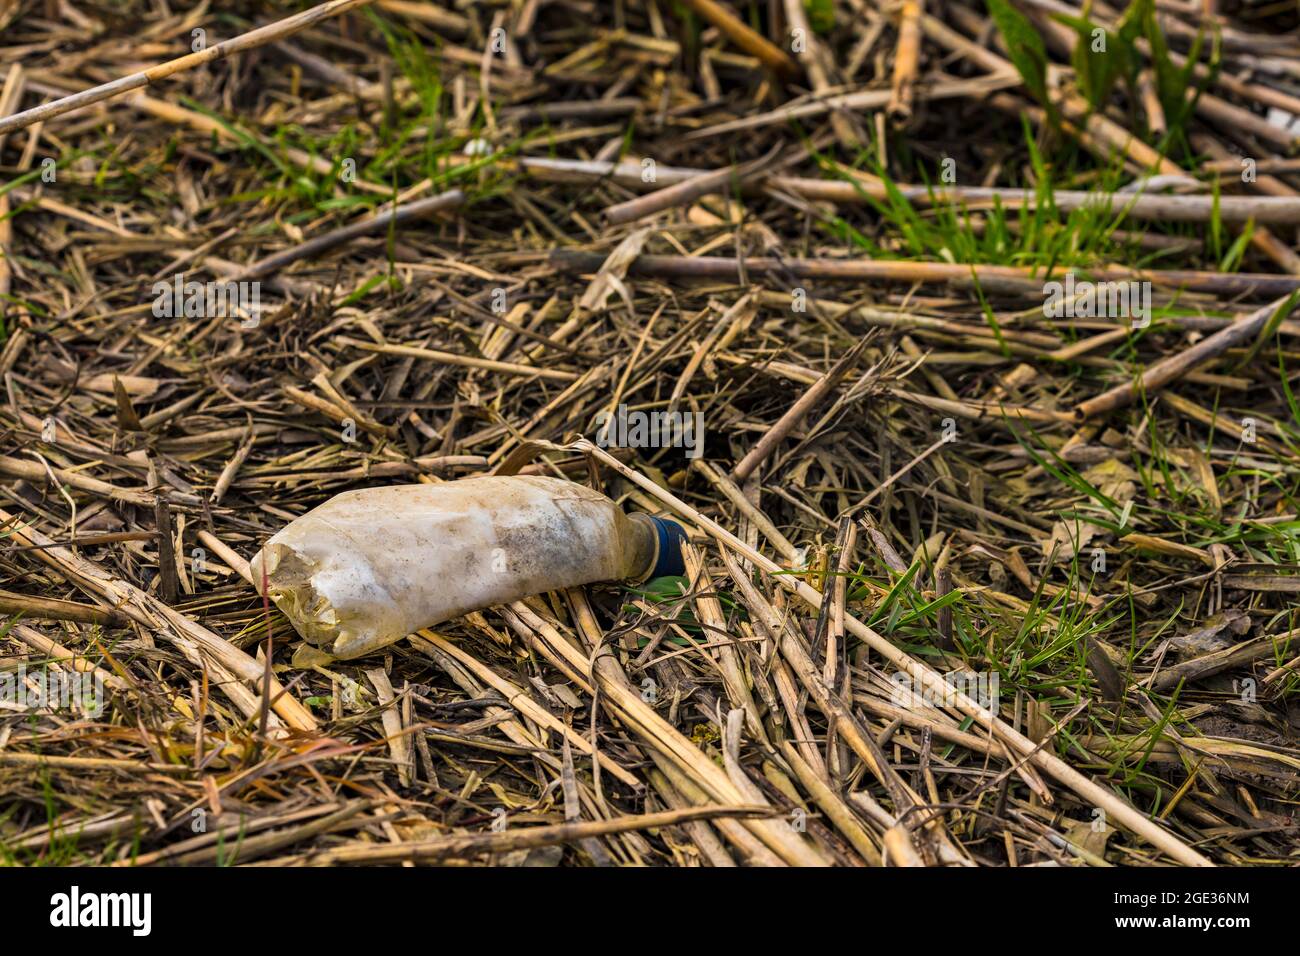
251, 476, 685, 659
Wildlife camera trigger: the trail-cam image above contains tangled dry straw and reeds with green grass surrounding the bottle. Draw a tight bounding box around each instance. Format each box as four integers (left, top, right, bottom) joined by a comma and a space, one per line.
0, 0, 1300, 866
